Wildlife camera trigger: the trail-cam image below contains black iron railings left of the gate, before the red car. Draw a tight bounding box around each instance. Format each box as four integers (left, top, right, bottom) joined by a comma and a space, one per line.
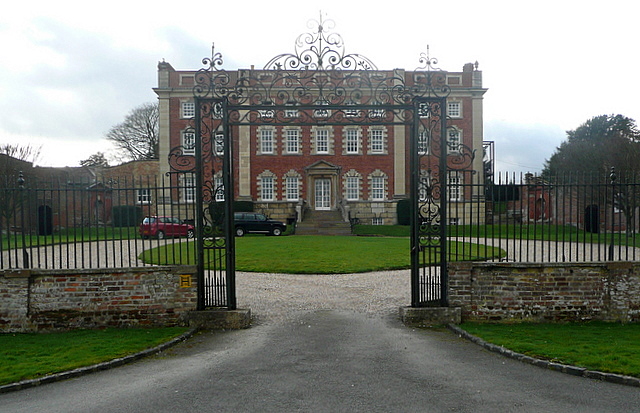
0, 171, 195, 269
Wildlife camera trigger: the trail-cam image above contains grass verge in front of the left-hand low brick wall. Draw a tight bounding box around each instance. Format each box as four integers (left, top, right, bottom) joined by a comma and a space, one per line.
0, 327, 187, 385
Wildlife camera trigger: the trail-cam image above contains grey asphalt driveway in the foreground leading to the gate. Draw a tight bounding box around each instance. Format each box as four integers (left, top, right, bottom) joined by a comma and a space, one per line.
0, 310, 640, 413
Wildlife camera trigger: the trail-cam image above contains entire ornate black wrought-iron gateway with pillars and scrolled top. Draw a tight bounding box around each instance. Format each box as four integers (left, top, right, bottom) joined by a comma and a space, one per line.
172, 20, 476, 309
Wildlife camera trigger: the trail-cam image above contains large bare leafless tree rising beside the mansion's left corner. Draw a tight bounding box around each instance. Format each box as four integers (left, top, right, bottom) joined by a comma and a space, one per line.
107, 103, 159, 160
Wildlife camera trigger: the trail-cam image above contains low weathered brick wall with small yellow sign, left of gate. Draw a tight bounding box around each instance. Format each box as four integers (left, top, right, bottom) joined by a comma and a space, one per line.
0, 266, 197, 332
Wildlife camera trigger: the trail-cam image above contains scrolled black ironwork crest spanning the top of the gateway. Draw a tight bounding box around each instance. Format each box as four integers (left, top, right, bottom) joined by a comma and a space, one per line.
193, 17, 451, 113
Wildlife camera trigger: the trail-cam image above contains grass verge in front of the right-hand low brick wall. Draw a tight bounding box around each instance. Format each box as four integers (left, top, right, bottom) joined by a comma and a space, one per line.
460, 321, 640, 377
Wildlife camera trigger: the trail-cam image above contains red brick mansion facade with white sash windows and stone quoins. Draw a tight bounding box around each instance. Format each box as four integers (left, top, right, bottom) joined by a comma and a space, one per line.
154, 62, 486, 224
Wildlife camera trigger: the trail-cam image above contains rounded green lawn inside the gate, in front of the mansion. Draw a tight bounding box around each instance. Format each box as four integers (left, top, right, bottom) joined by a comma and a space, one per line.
141, 235, 504, 274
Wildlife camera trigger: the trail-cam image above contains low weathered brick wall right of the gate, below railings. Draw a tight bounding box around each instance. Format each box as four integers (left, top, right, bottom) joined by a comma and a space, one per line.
449, 262, 640, 323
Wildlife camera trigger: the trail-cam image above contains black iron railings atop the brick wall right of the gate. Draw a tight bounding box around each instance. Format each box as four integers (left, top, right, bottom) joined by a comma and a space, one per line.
446, 170, 640, 262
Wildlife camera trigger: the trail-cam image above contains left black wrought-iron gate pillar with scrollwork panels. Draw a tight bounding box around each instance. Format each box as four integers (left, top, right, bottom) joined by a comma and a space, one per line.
188, 91, 237, 310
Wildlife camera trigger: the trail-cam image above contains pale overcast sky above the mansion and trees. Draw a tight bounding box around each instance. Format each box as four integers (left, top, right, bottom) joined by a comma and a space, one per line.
0, 0, 640, 172
